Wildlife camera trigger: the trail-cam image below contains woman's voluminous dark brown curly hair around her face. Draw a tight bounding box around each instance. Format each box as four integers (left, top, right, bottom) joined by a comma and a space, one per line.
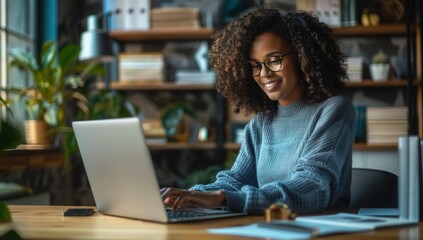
209, 8, 348, 114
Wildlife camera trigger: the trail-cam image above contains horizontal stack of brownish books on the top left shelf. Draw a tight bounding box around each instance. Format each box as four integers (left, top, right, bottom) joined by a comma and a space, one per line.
151, 7, 200, 29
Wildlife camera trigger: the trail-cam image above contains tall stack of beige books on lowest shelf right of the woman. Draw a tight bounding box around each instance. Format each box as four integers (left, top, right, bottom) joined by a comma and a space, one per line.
366, 107, 408, 144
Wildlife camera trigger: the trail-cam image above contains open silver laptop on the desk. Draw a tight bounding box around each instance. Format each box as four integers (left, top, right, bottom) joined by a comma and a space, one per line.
72, 118, 245, 223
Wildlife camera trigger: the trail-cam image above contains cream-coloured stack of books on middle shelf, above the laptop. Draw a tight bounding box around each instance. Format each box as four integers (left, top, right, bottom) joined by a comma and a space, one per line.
119, 53, 164, 82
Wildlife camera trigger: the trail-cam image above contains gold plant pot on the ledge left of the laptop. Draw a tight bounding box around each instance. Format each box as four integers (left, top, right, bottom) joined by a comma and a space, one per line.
24, 120, 54, 145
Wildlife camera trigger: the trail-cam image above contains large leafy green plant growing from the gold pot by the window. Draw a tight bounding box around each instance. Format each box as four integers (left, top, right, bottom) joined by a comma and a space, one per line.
2, 41, 104, 171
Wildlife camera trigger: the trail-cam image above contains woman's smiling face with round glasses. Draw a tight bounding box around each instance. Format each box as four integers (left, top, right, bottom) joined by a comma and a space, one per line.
250, 33, 303, 106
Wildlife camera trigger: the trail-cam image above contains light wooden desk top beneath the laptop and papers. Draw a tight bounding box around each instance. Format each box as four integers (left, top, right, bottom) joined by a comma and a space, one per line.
0, 206, 423, 240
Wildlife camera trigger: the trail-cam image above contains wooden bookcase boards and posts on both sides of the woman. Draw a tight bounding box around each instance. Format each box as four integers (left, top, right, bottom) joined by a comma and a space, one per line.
109, 9, 423, 156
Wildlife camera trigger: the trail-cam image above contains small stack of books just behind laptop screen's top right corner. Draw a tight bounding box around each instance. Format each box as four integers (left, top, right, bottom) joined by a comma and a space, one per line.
141, 119, 167, 144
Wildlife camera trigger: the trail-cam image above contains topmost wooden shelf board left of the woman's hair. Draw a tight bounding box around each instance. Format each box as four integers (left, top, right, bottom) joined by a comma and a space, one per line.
109, 28, 214, 41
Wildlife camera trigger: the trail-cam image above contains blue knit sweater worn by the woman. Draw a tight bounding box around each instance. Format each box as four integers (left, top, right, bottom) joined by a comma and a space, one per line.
191, 96, 355, 214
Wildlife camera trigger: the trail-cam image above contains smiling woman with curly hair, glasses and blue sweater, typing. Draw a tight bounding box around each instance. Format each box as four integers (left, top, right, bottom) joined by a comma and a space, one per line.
161, 9, 355, 214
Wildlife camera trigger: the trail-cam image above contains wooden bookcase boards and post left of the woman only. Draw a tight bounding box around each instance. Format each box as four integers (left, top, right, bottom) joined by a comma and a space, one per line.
109, 27, 223, 152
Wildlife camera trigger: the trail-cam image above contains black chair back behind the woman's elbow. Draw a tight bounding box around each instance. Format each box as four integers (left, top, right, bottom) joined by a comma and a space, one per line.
350, 168, 398, 209
